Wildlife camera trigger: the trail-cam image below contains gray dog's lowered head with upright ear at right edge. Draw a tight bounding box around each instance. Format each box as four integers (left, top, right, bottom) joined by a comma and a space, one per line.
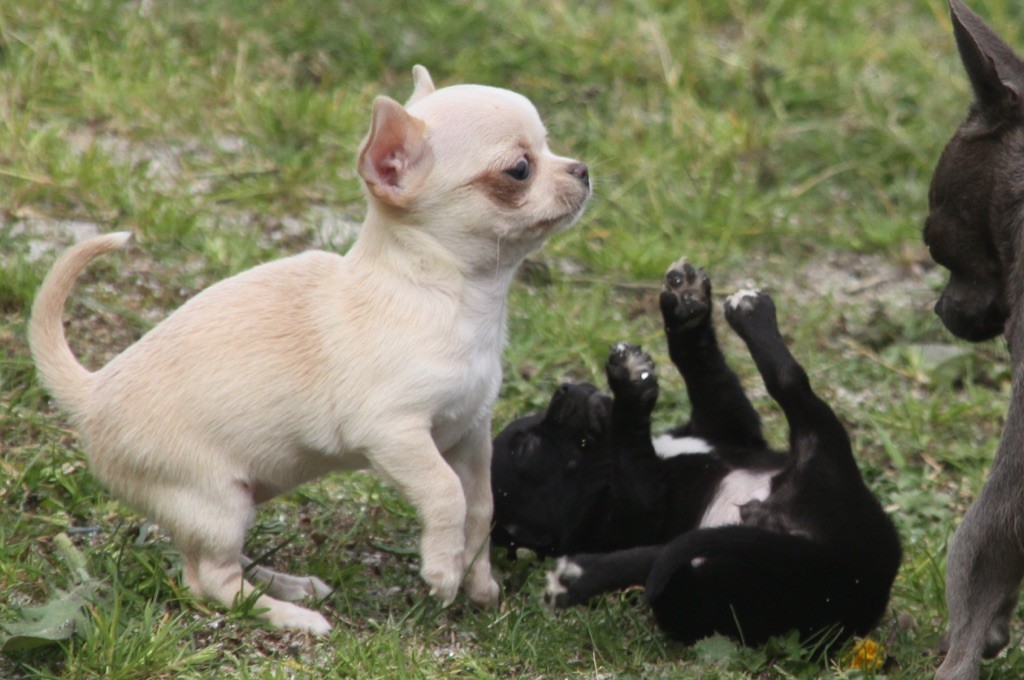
924, 0, 1024, 342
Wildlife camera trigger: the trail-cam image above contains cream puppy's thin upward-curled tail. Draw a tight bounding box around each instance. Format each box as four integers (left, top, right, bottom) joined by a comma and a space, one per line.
29, 231, 132, 415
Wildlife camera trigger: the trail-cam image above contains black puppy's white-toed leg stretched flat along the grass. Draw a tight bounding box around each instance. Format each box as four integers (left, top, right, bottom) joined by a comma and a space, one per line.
544, 546, 662, 609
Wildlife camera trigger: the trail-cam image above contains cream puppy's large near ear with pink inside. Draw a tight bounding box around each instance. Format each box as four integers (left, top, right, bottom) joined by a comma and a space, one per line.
358, 96, 433, 208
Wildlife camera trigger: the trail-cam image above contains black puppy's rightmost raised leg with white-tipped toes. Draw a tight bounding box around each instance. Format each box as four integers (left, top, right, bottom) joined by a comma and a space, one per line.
725, 290, 859, 476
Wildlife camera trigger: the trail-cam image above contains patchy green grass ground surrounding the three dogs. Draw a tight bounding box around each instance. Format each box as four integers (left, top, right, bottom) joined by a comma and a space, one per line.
0, 0, 1024, 678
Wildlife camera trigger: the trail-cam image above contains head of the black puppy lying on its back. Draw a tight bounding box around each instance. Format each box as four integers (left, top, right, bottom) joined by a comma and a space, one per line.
490, 383, 612, 555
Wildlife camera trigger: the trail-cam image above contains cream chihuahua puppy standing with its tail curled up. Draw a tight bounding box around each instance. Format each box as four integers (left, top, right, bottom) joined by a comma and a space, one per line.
29, 66, 590, 634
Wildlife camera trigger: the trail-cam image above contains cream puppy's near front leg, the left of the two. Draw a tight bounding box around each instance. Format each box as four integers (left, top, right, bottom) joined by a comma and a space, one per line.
372, 428, 466, 605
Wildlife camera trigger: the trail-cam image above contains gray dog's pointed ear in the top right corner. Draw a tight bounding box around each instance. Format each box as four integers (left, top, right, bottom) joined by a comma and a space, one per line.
949, 0, 1024, 117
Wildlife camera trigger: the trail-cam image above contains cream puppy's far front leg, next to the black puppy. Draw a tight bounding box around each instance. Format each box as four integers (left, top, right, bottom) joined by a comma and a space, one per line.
446, 415, 499, 606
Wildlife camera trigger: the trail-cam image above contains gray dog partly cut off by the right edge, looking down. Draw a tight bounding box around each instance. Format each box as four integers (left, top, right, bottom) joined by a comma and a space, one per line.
924, 0, 1024, 680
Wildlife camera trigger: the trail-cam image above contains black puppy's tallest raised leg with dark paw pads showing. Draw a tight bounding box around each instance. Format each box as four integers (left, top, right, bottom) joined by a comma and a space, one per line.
659, 258, 765, 447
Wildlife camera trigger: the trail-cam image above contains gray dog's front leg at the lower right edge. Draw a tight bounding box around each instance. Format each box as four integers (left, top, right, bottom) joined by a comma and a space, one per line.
936, 368, 1024, 680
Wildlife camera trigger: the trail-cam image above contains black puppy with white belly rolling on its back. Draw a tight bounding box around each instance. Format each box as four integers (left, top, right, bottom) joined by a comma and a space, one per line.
492, 260, 901, 646
